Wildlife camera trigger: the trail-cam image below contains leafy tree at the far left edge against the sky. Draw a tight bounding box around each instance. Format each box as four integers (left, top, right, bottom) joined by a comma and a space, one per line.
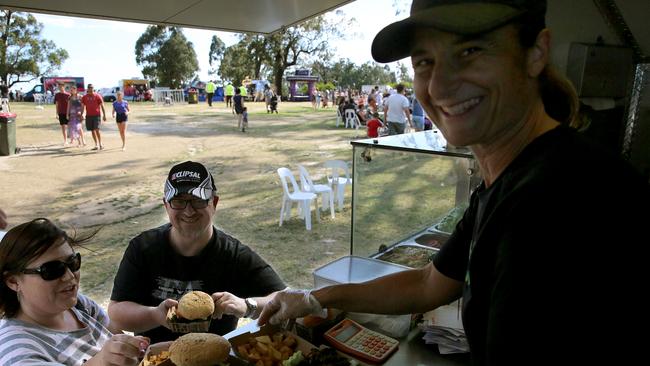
0, 10, 68, 87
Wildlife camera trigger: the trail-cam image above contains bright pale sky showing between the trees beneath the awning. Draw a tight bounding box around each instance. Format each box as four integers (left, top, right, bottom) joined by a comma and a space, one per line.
13, 0, 410, 91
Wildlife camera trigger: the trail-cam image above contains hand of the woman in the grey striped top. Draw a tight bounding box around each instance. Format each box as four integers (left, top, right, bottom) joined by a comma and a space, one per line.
85, 334, 149, 366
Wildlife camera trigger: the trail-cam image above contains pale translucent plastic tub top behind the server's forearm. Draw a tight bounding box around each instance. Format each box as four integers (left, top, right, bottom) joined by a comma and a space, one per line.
314, 255, 410, 283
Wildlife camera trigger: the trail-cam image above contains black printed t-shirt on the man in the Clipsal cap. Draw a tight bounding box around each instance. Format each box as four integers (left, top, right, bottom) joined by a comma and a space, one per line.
111, 224, 286, 343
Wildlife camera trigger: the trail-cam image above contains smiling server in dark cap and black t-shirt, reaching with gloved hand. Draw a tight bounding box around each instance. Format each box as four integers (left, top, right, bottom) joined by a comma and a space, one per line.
259, 0, 650, 365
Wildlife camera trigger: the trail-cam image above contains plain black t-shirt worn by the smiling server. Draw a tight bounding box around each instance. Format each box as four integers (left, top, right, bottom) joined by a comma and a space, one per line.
434, 127, 650, 365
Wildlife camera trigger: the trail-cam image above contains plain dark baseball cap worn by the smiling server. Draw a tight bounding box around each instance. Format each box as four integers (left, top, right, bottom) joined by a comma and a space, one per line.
371, 0, 546, 62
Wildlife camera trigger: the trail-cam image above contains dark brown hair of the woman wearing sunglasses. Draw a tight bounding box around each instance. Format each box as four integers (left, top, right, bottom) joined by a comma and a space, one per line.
0, 218, 98, 318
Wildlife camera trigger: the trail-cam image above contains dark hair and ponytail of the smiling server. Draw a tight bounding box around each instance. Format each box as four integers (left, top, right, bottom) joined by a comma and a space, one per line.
513, 12, 579, 126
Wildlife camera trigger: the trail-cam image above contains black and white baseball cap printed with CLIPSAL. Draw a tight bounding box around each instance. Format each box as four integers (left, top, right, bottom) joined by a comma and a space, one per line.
165, 161, 217, 202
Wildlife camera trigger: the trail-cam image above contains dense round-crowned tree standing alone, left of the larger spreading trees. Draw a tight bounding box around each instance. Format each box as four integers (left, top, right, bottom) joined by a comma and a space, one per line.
135, 25, 199, 87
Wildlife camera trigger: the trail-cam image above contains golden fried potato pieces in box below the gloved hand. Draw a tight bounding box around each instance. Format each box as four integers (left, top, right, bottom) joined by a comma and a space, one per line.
237, 332, 298, 366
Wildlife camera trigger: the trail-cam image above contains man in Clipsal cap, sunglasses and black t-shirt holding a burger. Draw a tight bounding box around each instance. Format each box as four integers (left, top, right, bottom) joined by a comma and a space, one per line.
108, 161, 286, 343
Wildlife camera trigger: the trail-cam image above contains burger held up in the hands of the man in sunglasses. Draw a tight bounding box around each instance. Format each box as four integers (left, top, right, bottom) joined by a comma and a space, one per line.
167, 291, 214, 333
